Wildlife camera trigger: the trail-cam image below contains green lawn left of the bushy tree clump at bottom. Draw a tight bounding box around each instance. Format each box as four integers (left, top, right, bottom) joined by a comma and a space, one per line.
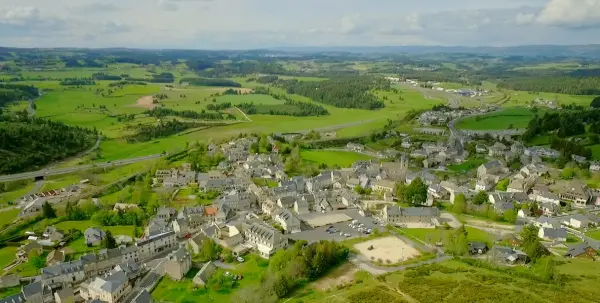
152, 256, 268, 303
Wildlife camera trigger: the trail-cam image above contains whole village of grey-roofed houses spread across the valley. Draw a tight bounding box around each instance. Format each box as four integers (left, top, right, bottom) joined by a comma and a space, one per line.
0, 127, 600, 303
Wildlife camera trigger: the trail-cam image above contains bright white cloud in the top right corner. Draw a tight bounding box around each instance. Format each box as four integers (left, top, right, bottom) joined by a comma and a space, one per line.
537, 0, 600, 27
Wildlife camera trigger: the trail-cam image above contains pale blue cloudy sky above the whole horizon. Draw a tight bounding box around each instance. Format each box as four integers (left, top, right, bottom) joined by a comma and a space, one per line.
0, 0, 600, 49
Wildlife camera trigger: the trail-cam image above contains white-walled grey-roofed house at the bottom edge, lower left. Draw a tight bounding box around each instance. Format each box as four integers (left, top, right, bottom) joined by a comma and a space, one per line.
79, 271, 131, 303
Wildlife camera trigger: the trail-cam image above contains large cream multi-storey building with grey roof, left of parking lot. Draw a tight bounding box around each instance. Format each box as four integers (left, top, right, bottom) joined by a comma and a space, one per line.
245, 223, 288, 259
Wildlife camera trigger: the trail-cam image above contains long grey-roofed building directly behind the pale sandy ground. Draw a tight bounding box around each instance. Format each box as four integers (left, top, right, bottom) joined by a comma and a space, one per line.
381, 205, 440, 227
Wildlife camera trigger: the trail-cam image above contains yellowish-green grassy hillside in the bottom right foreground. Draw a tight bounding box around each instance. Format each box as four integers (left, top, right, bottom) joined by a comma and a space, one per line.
288, 258, 600, 303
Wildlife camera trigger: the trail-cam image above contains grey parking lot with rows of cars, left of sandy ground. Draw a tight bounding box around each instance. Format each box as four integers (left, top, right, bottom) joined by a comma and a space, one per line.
287, 210, 385, 243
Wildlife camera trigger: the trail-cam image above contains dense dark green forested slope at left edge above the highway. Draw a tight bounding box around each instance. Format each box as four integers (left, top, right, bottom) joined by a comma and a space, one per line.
0, 114, 97, 174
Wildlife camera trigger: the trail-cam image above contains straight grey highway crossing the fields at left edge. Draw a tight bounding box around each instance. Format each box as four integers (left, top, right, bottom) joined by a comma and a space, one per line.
0, 154, 162, 182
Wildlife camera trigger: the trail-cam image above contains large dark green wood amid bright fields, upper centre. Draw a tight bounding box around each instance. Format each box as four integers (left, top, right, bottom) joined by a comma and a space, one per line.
277, 76, 389, 110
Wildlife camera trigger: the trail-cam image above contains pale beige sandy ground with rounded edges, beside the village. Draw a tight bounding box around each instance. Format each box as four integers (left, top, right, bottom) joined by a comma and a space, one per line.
354, 236, 421, 263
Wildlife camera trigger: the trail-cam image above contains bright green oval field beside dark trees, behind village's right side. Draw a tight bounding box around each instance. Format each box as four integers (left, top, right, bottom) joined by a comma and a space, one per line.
456, 108, 535, 130
